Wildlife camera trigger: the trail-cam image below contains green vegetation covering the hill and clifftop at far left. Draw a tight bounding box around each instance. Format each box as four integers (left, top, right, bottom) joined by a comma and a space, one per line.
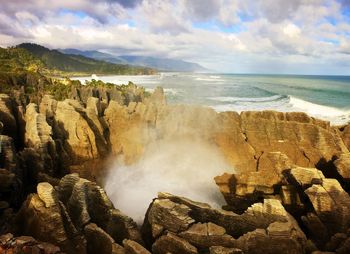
0, 43, 154, 102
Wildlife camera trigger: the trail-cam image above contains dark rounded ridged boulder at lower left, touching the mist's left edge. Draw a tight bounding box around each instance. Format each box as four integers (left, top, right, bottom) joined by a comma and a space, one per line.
58, 174, 142, 244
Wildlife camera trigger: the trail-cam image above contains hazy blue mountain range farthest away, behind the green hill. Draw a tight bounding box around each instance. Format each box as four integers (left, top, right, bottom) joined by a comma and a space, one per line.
59, 49, 208, 72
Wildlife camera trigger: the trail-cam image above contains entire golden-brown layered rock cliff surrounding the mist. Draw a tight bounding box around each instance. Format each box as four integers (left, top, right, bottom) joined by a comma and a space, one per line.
0, 84, 350, 254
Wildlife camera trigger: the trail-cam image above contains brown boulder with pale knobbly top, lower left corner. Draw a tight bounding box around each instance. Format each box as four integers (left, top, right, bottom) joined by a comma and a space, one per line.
16, 183, 85, 253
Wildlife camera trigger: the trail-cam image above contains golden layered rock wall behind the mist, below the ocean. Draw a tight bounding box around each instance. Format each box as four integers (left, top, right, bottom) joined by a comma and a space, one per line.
3, 86, 349, 181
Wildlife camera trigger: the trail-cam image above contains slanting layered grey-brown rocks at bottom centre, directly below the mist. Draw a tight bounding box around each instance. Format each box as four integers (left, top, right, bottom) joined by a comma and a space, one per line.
142, 193, 306, 253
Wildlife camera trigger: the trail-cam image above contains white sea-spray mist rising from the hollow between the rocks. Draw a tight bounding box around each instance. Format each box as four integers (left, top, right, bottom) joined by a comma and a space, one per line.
104, 138, 233, 223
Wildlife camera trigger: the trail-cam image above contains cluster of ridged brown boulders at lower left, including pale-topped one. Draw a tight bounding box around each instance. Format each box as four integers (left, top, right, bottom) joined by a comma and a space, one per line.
15, 174, 142, 253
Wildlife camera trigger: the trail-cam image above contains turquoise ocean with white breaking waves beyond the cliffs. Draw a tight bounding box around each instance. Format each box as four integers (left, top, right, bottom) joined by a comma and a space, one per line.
76, 73, 350, 125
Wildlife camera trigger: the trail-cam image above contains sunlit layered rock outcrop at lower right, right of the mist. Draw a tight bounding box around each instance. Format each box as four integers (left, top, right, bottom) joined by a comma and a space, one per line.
215, 153, 350, 253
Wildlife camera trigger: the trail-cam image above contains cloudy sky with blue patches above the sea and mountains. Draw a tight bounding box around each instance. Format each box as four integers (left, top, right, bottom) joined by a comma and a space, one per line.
0, 0, 350, 75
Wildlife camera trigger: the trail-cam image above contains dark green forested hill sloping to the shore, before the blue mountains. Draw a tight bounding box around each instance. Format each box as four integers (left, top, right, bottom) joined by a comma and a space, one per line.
16, 43, 155, 75
